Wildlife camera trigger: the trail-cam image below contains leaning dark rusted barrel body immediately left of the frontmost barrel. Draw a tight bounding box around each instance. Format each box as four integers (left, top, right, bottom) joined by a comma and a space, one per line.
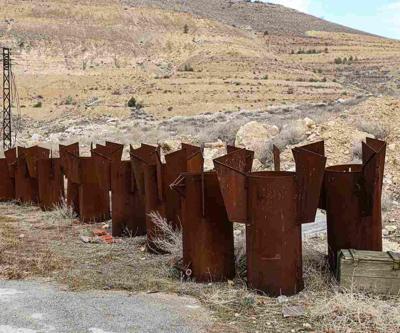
172, 172, 235, 282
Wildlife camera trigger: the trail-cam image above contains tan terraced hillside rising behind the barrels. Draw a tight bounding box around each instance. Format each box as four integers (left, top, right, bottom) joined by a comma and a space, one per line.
0, 0, 400, 123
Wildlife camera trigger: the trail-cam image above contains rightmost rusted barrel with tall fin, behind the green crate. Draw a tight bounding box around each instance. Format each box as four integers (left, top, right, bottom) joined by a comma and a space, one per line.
321, 138, 386, 270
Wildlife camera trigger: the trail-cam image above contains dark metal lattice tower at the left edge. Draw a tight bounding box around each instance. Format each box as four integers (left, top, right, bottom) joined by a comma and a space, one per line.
3, 47, 12, 149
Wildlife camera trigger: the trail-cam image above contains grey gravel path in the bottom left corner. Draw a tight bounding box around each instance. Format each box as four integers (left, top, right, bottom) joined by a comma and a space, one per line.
0, 281, 212, 333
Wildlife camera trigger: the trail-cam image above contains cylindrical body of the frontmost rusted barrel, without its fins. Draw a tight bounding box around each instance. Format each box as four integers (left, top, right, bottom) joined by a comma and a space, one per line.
246, 172, 304, 296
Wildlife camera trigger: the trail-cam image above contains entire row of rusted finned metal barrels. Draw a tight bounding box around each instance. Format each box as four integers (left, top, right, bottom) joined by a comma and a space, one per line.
0, 138, 386, 296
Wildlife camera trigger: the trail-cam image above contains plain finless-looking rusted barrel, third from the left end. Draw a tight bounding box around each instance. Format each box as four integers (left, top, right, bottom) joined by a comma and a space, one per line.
37, 158, 64, 210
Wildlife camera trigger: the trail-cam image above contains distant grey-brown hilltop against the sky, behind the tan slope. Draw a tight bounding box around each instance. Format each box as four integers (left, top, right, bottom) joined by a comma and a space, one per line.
127, 0, 368, 36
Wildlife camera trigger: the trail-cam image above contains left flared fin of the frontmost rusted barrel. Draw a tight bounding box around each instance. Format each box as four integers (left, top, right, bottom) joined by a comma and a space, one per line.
214, 149, 254, 223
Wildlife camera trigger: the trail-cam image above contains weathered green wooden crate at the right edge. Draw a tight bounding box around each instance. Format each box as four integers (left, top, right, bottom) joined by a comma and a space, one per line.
336, 250, 400, 295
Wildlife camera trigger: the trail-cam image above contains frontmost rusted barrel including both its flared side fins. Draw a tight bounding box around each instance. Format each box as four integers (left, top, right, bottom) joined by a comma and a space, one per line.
214, 143, 326, 296
